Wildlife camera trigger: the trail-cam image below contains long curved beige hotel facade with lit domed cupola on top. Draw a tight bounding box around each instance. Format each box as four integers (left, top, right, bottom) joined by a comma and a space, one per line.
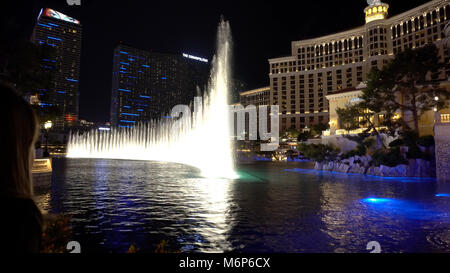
269, 0, 450, 131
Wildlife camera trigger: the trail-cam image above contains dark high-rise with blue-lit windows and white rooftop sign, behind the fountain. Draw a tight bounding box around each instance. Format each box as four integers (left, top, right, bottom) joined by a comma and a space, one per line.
111, 44, 209, 127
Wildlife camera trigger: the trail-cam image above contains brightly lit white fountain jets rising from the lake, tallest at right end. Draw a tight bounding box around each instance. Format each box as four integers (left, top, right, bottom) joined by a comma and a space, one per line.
67, 21, 237, 178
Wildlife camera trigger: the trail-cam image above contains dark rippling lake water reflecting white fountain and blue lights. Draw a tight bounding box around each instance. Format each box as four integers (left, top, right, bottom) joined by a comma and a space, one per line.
37, 159, 450, 252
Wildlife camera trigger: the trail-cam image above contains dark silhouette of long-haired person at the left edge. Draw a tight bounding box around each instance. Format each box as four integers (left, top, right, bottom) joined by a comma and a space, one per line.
0, 84, 42, 253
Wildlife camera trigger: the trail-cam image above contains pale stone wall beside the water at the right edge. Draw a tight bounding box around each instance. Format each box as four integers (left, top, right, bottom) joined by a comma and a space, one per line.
434, 123, 450, 182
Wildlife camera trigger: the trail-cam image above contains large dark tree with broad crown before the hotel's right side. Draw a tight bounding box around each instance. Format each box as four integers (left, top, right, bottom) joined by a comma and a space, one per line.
372, 44, 450, 132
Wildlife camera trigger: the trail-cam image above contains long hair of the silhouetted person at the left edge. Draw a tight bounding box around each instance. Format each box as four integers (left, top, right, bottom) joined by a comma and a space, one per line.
0, 85, 39, 198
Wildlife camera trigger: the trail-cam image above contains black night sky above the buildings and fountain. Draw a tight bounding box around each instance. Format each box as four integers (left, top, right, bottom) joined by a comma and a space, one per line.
6, 0, 427, 122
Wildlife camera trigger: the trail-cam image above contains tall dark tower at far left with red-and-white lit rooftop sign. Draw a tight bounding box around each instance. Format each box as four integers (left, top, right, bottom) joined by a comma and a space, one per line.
32, 8, 82, 129
